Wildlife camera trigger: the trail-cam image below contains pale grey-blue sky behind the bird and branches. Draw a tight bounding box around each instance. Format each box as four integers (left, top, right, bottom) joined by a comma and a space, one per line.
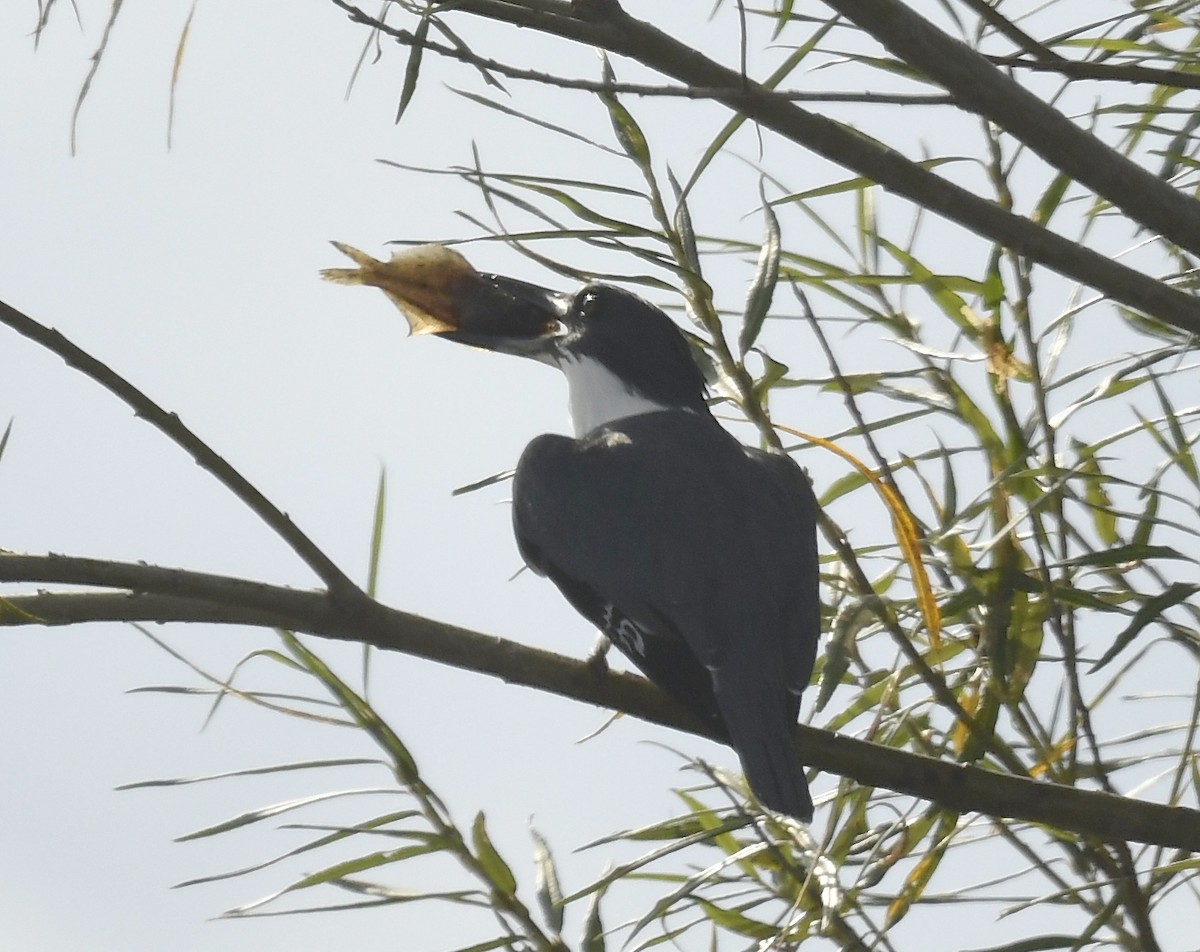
0, 0, 1195, 952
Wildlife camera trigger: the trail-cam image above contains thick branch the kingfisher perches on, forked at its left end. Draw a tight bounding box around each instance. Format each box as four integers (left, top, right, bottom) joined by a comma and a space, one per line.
0, 553, 1200, 851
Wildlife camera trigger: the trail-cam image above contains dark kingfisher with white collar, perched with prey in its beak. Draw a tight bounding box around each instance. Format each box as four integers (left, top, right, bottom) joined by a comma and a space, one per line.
436, 275, 821, 820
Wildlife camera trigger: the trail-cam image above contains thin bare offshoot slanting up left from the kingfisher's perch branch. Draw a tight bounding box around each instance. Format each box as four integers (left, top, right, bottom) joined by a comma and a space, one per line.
0, 295, 366, 603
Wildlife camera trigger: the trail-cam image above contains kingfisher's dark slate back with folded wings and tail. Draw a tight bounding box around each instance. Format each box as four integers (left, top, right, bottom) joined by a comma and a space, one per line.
514, 412, 818, 818
